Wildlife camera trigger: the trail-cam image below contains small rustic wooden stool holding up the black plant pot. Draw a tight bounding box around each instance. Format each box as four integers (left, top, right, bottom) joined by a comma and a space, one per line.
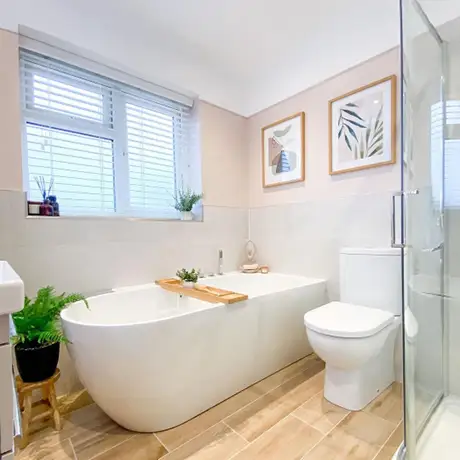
16, 369, 61, 449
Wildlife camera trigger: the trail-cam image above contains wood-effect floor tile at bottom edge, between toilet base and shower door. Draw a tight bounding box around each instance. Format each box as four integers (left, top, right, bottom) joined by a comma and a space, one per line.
302, 412, 395, 460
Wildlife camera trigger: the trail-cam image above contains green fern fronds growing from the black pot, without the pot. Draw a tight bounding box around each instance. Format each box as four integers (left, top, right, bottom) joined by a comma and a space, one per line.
11, 286, 88, 344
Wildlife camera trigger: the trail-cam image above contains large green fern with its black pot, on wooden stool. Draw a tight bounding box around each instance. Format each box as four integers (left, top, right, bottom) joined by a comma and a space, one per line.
11, 286, 88, 382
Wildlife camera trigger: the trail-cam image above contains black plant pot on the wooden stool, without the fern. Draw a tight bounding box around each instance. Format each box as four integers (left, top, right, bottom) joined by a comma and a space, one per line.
14, 342, 60, 383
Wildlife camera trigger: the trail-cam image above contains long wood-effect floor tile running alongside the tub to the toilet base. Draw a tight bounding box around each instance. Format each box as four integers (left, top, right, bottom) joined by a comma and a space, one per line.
225, 362, 324, 442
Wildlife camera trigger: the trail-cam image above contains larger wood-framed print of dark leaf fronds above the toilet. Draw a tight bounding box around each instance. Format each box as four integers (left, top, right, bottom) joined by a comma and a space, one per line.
329, 75, 396, 174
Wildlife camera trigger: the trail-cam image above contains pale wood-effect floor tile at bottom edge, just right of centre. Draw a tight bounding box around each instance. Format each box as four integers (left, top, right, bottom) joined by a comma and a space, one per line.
232, 416, 323, 460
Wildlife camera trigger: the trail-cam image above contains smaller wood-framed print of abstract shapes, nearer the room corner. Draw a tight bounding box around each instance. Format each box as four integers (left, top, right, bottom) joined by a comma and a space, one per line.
262, 112, 305, 187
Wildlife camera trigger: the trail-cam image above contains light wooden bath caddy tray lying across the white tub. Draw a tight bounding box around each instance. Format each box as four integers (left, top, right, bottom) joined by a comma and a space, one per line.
155, 278, 248, 303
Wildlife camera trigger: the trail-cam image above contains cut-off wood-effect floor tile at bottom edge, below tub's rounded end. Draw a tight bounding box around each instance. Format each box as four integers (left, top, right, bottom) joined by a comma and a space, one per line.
90, 434, 168, 460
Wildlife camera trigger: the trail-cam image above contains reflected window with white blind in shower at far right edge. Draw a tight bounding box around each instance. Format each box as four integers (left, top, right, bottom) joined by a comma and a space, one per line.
431, 100, 460, 208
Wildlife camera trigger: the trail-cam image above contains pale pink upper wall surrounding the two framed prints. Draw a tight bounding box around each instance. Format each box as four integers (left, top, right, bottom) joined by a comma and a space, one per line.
248, 49, 400, 207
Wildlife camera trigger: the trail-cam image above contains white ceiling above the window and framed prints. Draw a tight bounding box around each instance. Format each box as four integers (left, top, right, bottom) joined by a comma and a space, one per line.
0, 0, 460, 116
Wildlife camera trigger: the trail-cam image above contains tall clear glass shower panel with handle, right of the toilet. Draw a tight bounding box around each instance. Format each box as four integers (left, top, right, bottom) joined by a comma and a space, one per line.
402, 0, 445, 454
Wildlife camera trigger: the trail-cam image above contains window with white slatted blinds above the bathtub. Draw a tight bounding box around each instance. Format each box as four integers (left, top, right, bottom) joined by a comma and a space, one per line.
21, 51, 191, 218
